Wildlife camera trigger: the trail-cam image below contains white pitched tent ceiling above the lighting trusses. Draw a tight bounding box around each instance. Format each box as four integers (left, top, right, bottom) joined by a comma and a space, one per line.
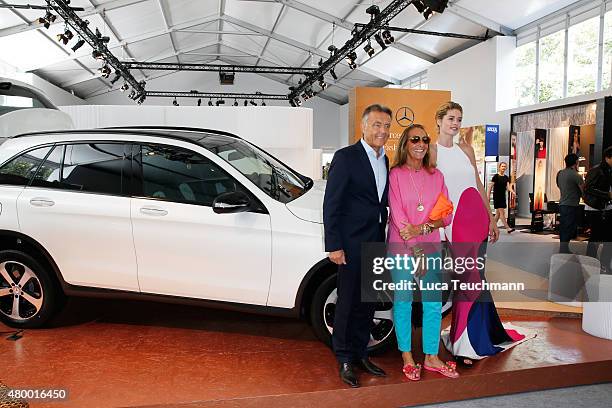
0, 0, 584, 103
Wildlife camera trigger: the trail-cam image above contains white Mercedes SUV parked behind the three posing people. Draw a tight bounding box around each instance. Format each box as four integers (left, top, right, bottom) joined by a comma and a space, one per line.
0, 127, 394, 351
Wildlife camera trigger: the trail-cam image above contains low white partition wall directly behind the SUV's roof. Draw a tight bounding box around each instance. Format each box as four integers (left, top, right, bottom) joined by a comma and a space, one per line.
61, 105, 321, 179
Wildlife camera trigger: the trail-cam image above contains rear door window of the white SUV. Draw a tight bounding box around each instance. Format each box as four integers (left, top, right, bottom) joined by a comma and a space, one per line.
61, 143, 126, 195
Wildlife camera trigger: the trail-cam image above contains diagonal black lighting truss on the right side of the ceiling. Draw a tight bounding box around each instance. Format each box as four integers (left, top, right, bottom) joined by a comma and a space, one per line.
289, 0, 412, 101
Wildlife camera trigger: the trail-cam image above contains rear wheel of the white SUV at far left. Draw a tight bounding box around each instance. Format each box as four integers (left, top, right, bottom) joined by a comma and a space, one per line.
0, 250, 64, 329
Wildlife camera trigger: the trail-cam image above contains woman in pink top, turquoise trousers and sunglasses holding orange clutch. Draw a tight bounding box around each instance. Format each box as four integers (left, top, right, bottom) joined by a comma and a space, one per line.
388, 124, 458, 381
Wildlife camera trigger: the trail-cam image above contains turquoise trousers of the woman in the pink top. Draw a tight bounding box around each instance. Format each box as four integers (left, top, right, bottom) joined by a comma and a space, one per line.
391, 253, 442, 354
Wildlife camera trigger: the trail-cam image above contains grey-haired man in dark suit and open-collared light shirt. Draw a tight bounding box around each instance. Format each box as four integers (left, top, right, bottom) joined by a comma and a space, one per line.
323, 105, 392, 387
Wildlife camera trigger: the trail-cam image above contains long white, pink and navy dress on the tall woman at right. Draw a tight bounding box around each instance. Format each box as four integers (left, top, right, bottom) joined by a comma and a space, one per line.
437, 143, 532, 360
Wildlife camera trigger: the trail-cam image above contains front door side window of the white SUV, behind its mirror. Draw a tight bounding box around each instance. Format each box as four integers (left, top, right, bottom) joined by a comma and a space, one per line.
140, 145, 244, 206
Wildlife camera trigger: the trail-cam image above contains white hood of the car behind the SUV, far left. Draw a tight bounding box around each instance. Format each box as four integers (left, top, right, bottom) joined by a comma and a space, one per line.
0, 108, 74, 138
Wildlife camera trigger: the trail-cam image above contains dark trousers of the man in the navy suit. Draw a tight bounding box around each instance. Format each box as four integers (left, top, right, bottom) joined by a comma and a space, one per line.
332, 225, 385, 363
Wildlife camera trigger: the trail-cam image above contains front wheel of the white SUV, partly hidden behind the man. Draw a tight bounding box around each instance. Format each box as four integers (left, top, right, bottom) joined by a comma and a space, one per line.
310, 274, 395, 354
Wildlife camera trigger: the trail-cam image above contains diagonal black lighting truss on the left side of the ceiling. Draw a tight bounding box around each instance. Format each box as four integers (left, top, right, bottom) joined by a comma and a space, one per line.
46, 0, 145, 99
